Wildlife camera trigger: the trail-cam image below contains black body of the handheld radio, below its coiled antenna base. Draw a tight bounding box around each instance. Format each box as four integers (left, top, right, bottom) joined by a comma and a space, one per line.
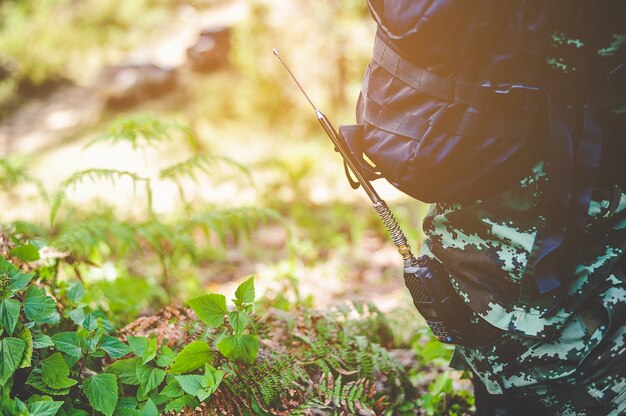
404, 256, 502, 347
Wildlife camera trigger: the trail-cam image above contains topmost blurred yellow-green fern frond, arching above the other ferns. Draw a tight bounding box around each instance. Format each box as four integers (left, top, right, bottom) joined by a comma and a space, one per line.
86, 114, 193, 149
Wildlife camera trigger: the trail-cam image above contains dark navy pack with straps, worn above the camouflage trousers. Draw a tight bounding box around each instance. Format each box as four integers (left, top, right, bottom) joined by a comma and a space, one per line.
348, 0, 626, 308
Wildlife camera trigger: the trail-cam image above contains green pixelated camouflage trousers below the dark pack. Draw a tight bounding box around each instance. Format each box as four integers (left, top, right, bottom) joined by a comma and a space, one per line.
422, 163, 626, 415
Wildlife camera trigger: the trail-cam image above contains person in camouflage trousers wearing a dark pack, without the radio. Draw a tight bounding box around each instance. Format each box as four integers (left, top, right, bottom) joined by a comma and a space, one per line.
346, 0, 626, 415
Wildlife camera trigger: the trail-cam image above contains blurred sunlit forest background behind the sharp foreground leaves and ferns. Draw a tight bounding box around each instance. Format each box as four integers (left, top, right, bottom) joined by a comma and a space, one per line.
0, 0, 424, 318
